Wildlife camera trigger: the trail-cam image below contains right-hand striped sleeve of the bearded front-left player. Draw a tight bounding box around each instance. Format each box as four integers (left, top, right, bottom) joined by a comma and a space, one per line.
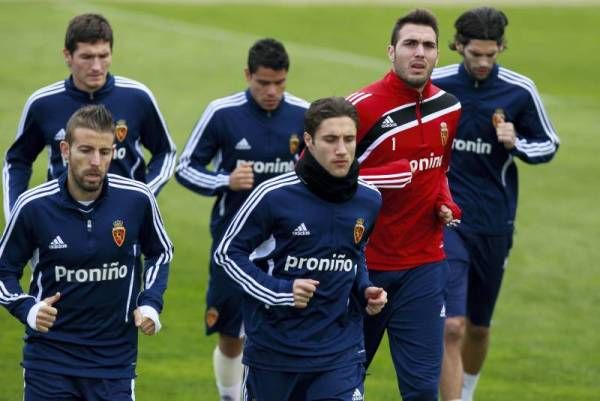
138, 194, 173, 313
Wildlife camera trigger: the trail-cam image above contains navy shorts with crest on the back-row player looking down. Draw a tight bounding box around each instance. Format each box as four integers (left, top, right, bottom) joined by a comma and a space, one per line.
204, 243, 244, 338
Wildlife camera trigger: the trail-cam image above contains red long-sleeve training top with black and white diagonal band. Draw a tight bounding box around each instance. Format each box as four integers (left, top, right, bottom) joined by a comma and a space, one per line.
348, 71, 461, 270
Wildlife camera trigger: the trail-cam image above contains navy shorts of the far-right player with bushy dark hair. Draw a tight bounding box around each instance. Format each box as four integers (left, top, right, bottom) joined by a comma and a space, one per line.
444, 228, 512, 327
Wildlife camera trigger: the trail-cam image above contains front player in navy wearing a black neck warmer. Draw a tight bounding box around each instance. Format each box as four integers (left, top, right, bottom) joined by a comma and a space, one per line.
215, 98, 387, 401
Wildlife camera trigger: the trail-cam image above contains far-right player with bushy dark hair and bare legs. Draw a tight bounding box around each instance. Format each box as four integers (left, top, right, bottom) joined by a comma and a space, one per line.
433, 7, 559, 401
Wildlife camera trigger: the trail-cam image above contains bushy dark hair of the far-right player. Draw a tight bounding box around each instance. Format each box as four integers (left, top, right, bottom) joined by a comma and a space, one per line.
449, 7, 508, 50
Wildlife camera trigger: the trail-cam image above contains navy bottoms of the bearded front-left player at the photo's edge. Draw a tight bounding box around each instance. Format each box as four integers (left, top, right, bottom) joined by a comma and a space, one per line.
24, 369, 135, 401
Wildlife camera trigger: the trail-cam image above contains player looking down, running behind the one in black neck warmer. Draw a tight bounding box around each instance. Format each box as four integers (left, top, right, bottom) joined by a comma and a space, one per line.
175, 39, 308, 401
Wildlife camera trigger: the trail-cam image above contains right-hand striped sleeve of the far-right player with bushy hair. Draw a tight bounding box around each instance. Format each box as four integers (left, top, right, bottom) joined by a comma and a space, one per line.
511, 81, 559, 164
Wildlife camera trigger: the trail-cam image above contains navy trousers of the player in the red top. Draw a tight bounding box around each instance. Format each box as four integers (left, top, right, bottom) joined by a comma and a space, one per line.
364, 261, 448, 401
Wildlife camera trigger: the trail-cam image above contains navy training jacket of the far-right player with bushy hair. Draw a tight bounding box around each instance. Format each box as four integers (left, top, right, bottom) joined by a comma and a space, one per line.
433, 64, 559, 235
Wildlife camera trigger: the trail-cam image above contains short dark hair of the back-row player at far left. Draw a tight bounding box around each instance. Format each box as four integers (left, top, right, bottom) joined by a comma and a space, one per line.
65, 14, 113, 54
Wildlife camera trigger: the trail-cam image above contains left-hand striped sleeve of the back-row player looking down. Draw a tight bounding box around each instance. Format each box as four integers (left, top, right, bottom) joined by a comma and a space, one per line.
175, 102, 229, 196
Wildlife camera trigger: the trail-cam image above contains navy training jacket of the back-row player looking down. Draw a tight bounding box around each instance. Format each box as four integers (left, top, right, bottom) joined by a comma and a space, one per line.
175, 90, 309, 241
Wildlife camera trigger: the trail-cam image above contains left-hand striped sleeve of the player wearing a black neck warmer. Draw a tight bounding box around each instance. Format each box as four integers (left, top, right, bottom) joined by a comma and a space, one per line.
214, 185, 294, 306
